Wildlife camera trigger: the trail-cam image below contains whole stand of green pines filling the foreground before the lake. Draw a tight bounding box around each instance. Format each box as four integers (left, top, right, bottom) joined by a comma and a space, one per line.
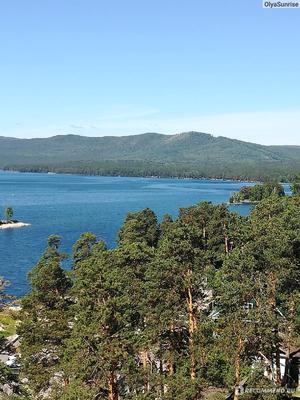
1, 178, 300, 400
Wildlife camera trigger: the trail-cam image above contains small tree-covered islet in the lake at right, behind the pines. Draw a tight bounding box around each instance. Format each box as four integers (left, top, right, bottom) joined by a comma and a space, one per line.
229, 182, 285, 204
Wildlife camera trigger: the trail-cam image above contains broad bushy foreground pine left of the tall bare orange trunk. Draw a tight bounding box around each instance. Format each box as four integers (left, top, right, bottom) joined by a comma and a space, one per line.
60, 238, 152, 400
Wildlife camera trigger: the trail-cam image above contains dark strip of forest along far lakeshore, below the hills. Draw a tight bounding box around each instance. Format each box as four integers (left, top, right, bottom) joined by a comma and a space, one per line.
3, 160, 300, 182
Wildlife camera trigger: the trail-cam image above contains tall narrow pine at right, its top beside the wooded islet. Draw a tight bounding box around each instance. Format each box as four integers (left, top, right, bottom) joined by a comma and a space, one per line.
250, 197, 294, 384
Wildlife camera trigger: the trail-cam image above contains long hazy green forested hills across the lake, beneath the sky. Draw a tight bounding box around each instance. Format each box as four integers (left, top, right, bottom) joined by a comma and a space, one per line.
0, 132, 300, 178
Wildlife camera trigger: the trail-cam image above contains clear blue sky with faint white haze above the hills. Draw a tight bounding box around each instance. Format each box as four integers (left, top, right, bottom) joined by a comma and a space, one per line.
0, 0, 300, 145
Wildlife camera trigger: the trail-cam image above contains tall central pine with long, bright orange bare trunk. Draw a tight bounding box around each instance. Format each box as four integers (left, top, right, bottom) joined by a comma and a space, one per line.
148, 208, 213, 398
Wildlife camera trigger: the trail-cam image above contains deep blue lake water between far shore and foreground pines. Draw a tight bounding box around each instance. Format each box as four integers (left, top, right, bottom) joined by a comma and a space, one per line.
0, 172, 253, 296
